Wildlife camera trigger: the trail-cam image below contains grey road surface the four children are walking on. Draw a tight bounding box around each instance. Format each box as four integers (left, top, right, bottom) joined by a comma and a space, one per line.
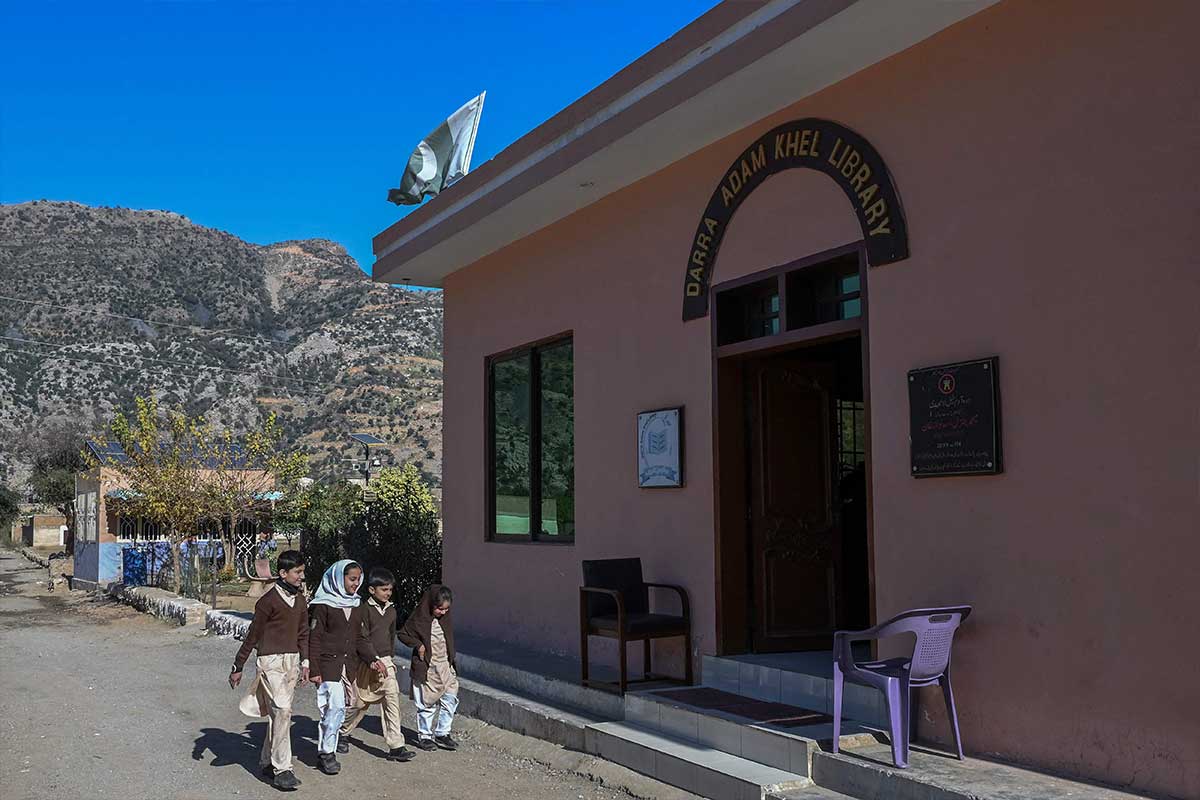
0, 551, 690, 800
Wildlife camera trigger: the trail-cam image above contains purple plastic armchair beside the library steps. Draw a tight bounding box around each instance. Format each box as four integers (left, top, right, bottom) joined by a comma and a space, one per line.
833, 606, 971, 769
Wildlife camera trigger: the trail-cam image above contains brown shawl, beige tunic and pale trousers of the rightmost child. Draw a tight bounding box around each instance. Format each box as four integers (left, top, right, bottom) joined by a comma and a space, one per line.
398, 584, 458, 740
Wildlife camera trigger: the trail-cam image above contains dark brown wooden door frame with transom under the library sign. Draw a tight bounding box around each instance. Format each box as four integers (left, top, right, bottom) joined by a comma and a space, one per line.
709, 241, 877, 655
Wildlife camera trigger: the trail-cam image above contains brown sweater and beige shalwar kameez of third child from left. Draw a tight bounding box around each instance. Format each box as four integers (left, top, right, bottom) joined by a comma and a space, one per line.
342, 597, 404, 751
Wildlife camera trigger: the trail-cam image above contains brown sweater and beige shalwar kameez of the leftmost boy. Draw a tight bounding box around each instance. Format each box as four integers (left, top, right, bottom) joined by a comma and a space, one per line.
233, 582, 308, 772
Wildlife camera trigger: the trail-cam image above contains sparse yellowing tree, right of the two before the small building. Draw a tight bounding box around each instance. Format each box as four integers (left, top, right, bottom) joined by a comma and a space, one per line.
202, 414, 307, 569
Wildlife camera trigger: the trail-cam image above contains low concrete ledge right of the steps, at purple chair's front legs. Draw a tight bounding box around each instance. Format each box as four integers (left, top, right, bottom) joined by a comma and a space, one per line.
812, 744, 1142, 800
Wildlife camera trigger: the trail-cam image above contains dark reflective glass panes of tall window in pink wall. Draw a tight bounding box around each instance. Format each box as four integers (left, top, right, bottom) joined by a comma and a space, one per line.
488, 339, 575, 542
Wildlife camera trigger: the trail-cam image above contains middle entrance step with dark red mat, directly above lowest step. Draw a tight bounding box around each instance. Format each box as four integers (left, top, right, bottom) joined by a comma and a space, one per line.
625, 690, 877, 776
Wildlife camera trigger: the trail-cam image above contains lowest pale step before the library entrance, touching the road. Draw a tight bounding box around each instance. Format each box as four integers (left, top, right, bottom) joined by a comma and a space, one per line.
588, 722, 812, 800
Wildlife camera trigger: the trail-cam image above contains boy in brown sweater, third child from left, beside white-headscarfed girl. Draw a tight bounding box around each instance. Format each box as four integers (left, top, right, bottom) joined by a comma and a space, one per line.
337, 566, 415, 762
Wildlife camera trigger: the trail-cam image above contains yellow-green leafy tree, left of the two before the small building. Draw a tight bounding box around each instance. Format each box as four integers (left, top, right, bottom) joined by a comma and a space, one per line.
89, 396, 211, 594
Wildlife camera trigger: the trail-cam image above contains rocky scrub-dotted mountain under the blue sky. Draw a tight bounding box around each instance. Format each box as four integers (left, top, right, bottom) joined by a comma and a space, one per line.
0, 201, 442, 485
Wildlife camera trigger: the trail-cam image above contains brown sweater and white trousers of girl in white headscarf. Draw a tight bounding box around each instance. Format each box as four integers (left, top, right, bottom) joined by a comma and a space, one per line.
308, 587, 362, 753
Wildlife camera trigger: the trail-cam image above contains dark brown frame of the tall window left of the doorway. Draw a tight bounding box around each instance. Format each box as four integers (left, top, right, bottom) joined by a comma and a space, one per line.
484, 331, 575, 546
